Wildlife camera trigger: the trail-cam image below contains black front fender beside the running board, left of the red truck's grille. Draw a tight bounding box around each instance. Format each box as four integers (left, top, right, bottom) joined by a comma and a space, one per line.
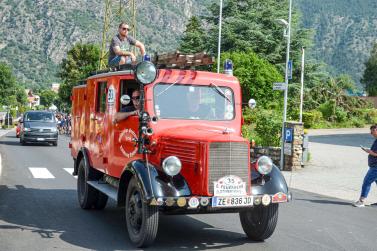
118, 160, 191, 204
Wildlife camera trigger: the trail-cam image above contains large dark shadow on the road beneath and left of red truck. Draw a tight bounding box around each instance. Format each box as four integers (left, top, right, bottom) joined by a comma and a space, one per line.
0, 185, 251, 250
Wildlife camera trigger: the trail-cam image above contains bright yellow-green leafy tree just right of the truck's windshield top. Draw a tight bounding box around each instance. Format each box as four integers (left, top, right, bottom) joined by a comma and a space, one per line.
217, 51, 283, 107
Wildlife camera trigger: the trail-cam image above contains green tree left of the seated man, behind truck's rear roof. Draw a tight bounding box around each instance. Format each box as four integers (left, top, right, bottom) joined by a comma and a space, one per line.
59, 43, 100, 107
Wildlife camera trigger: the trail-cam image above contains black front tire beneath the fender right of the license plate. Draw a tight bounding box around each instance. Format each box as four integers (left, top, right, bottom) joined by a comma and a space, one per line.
240, 204, 279, 241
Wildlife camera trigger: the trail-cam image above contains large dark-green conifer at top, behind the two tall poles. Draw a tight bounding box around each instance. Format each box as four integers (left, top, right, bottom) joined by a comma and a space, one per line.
206, 0, 312, 64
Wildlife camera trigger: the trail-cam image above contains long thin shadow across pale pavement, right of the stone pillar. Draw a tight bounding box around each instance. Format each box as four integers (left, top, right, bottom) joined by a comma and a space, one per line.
309, 133, 373, 147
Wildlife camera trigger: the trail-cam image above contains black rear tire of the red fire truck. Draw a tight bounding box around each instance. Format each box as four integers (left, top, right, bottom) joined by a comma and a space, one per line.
77, 158, 98, 209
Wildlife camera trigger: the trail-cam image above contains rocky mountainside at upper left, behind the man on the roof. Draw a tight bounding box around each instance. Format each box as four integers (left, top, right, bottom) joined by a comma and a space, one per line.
0, 0, 206, 87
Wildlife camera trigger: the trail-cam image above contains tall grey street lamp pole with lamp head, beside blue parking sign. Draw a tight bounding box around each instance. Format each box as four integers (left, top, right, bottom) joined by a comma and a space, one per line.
276, 0, 292, 170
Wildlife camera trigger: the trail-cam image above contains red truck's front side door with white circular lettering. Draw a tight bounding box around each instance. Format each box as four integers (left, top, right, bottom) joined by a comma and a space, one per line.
108, 79, 140, 177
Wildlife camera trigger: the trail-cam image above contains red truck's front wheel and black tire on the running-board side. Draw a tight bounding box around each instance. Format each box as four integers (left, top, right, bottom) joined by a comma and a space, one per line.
125, 177, 159, 248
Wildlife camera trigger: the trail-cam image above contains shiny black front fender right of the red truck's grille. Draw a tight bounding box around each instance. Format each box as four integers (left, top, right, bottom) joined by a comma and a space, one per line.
251, 165, 288, 195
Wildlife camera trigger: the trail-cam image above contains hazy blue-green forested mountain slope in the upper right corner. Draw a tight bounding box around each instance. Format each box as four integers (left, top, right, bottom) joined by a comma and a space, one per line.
297, 0, 377, 85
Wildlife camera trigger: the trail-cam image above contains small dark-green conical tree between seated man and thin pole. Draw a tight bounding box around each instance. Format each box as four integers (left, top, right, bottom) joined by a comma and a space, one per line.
179, 16, 206, 53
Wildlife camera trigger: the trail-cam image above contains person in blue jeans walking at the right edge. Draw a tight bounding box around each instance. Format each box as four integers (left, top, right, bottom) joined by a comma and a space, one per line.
353, 125, 377, 207
